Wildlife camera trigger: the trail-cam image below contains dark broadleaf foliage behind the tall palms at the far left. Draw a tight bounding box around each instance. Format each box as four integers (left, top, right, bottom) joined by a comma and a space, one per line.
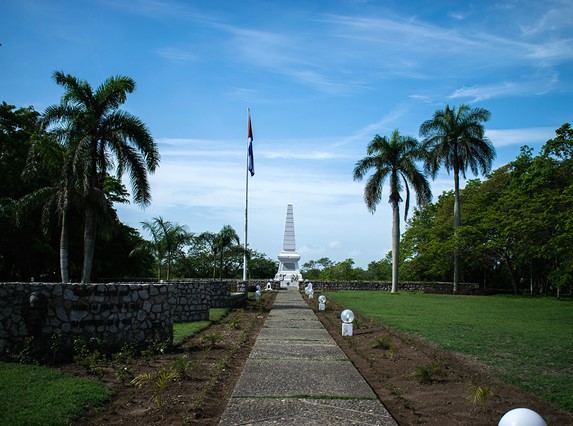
0, 98, 150, 281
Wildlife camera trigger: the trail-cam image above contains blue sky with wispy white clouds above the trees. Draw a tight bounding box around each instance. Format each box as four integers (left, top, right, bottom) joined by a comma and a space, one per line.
0, 0, 573, 267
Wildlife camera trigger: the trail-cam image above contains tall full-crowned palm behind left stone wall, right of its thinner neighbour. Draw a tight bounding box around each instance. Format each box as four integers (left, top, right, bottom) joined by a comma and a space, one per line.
44, 71, 159, 282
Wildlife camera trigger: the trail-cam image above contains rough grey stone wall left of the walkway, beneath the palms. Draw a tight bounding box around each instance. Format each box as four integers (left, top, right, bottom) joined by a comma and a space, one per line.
0, 281, 247, 354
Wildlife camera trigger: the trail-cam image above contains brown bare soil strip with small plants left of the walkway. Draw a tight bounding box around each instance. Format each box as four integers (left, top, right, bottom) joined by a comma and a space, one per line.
69, 292, 275, 426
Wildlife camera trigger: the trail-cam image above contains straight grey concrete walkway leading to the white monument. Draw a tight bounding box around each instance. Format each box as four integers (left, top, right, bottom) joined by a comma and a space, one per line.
219, 288, 397, 426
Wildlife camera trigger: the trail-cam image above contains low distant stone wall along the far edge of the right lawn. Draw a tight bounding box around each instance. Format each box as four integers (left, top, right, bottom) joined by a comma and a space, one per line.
299, 280, 479, 294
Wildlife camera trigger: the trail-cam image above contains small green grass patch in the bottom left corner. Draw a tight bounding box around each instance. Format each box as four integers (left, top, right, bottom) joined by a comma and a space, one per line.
0, 362, 113, 426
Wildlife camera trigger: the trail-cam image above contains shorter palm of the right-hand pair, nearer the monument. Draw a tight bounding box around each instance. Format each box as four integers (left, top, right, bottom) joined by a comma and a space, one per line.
354, 130, 432, 293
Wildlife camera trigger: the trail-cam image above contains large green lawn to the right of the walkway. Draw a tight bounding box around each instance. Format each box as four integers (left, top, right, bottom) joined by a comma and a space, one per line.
326, 291, 573, 412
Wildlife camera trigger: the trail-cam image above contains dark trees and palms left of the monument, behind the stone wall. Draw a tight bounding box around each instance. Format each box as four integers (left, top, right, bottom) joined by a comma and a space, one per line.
0, 71, 278, 282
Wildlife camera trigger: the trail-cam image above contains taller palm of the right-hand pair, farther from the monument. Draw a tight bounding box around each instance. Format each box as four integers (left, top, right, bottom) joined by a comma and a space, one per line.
420, 104, 495, 293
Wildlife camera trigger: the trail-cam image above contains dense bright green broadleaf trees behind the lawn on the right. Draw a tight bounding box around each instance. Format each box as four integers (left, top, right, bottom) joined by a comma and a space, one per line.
401, 124, 573, 293
